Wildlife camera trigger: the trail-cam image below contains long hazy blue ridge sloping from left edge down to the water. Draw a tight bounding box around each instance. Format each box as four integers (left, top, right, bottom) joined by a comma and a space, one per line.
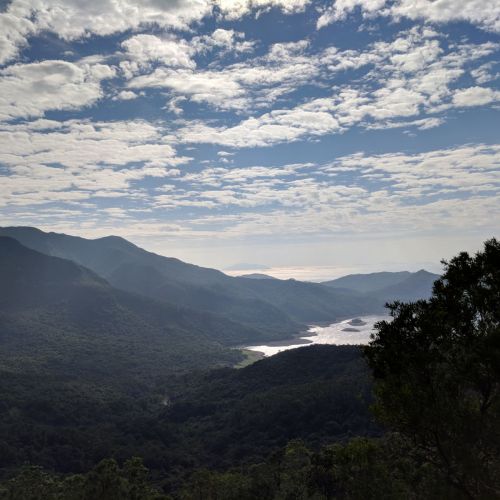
0, 227, 381, 339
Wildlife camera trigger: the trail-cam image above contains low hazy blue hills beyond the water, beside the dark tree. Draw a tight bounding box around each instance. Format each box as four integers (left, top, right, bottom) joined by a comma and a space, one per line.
322, 269, 439, 301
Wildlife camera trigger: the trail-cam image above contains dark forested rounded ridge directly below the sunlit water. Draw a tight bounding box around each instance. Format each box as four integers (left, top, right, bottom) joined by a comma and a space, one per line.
164, 345, 380, 467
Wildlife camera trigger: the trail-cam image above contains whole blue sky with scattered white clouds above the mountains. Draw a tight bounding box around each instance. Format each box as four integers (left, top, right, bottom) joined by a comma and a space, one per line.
0, 0, 500, 280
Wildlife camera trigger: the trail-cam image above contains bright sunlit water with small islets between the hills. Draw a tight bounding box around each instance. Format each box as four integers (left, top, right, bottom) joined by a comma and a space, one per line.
246, 315, 388, 356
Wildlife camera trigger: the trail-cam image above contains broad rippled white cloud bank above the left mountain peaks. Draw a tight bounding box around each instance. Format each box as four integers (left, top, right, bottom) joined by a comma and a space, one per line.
0, 120, 190, 206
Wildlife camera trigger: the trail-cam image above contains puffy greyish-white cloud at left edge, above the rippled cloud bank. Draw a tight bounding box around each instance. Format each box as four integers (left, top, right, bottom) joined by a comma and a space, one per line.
0, 60, 115, 120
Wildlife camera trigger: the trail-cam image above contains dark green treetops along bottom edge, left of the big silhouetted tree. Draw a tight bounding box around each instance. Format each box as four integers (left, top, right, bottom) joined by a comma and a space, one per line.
176, 435, 458, 500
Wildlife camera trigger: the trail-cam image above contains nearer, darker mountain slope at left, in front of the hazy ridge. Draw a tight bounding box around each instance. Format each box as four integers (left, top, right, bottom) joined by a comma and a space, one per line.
0, 237, 266, 381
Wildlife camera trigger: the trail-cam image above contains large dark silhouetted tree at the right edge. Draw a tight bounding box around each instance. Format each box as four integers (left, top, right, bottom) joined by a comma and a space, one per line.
365, 239, 500, 499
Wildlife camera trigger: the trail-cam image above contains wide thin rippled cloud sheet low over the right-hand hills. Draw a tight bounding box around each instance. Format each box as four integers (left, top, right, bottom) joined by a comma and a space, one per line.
146, 144, 500, 239
